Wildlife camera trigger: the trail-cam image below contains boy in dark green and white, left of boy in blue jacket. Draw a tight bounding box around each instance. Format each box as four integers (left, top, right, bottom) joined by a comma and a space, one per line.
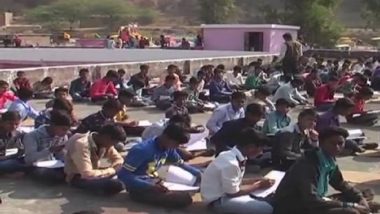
184, 77, 211, 113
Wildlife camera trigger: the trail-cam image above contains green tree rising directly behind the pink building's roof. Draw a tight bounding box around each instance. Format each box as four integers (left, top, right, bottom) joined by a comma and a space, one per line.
199, 0, 237, 24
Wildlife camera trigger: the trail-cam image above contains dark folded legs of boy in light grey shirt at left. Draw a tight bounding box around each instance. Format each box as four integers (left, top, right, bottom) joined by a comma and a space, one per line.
29, 167, 65, 185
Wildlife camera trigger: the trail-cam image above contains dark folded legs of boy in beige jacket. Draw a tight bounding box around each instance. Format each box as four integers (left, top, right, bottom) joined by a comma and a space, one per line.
70, 176, 124, 195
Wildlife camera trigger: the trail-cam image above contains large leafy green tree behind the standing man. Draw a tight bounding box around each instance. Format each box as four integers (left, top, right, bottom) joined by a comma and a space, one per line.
255, 0, 342, 47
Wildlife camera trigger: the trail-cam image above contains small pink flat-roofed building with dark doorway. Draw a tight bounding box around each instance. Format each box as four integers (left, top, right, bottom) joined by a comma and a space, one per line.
201, 24, 300, 53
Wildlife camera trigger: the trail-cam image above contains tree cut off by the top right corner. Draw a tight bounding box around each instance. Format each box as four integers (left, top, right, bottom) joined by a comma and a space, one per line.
362, 0, 380, 30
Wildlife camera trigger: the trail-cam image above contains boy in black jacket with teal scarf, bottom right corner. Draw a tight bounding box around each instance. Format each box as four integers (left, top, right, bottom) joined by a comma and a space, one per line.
274, 127, 377, 214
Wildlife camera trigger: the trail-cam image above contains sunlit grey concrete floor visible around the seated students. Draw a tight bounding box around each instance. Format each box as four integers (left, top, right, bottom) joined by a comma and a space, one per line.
0, 100, 380, 214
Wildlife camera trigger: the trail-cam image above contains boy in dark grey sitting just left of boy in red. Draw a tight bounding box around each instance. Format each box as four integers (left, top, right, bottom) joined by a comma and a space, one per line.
69, 68, 91, 102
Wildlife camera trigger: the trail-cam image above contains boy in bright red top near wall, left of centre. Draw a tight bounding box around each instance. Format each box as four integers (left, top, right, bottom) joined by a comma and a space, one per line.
90, 70, 119, 102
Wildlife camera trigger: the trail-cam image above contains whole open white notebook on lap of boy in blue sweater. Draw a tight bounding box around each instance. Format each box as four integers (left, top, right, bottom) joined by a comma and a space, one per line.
164, 166, 199, 191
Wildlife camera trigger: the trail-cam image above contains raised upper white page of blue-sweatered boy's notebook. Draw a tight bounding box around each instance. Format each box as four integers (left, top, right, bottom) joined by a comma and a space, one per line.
165, 166, 197, 186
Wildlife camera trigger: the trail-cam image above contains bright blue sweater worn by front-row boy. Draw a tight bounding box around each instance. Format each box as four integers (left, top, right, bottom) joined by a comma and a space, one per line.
118, 138, 201, 190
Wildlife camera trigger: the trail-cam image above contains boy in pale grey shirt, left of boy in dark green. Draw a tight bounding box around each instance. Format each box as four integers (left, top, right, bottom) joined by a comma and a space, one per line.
152, 75, 176, 111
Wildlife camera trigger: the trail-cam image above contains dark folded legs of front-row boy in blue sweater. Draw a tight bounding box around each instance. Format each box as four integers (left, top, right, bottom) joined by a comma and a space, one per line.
129, 189, 193, 209
